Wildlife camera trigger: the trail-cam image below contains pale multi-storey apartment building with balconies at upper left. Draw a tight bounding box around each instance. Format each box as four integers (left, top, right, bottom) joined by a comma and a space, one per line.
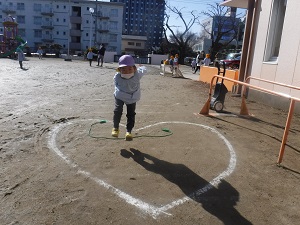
0, 0, 124, 54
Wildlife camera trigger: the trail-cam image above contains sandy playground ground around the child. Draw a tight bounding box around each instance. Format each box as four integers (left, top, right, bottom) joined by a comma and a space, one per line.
0, 58, 300, 225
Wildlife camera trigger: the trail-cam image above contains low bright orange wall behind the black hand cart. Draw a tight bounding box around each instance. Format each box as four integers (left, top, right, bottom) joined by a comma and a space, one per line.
199, 66, 239, 91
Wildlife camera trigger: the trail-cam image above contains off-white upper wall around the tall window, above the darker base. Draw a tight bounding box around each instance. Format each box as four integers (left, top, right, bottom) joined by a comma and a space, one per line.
247, 0, 300, 98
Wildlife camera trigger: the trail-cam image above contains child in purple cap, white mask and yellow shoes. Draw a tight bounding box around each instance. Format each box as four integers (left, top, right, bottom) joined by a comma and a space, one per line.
111, 55, 146, 141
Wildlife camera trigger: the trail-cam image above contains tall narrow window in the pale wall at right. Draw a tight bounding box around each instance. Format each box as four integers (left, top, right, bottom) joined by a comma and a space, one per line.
264, 0, 287, 61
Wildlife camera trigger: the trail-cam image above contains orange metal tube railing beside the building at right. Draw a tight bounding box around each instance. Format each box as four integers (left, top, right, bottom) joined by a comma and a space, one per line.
200, 75, 300, 164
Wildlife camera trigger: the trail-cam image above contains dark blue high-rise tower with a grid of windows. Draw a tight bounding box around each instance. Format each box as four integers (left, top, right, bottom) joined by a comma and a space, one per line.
110, 0, 165, 53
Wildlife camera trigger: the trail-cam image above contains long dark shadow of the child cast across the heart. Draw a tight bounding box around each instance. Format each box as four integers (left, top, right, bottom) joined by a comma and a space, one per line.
121, 148, 252, 225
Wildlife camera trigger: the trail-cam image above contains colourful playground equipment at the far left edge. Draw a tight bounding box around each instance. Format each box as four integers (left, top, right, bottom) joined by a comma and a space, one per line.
0, 15, 27, 58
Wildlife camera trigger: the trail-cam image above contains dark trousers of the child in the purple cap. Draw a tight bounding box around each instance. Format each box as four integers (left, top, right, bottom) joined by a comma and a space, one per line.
113, 98, 136, 132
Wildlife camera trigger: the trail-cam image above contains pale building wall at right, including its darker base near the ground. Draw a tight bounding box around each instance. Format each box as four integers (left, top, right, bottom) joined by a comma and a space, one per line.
245, 0, 300, 112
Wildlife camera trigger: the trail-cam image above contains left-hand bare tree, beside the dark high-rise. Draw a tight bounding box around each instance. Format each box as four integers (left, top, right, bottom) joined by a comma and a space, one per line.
164, 5, 199, 64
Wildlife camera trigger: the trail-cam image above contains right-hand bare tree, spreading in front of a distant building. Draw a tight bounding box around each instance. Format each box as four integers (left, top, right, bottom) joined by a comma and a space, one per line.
199, 3, 240, 58
